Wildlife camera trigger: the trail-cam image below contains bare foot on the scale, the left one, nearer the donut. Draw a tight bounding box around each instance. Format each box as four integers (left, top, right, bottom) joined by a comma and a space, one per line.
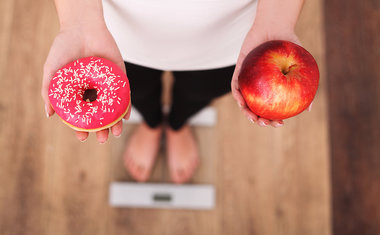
124, 123, 162, 182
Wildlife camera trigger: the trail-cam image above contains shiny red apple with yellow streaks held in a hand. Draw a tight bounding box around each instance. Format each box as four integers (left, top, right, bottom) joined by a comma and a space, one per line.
238, 40, 319, 120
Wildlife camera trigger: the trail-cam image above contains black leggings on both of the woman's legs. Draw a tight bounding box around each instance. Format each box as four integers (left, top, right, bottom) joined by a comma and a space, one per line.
125, 62, 235, 130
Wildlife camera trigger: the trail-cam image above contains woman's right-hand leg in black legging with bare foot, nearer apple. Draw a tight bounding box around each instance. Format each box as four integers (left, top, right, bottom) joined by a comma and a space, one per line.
166, 66, 234, 183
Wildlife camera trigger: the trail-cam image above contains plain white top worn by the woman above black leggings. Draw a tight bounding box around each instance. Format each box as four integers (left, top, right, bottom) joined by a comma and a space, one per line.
103, 0, 257, 71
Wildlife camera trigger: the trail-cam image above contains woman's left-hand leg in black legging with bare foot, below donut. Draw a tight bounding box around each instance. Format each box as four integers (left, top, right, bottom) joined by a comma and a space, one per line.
124, 63, 162, 181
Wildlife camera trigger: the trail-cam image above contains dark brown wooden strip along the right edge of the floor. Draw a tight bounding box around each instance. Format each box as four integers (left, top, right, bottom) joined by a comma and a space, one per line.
325, 0, 380, 234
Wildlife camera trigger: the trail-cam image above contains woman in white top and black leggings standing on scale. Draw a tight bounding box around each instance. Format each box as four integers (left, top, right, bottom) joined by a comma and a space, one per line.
42, 0, 303, 183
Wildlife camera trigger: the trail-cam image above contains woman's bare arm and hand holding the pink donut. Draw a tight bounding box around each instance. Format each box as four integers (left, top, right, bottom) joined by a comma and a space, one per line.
41, 0, 129, 143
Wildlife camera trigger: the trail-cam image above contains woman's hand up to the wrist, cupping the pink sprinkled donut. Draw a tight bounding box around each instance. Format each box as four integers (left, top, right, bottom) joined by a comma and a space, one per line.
41, 9, 130, 143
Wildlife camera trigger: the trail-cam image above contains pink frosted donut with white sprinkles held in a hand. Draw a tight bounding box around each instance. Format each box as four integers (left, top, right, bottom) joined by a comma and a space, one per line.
49, 57, 131, 132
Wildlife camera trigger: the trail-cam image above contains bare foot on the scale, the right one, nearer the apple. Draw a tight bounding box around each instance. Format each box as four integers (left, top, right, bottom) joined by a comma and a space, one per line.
166, 125, 199, 184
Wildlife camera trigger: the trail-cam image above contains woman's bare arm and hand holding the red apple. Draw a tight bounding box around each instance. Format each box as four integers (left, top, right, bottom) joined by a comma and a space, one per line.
231, 0, 303, 127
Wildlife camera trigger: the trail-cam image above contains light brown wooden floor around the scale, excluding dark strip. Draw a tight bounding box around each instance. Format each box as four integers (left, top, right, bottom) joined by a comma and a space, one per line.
0, 0, 331, 235
